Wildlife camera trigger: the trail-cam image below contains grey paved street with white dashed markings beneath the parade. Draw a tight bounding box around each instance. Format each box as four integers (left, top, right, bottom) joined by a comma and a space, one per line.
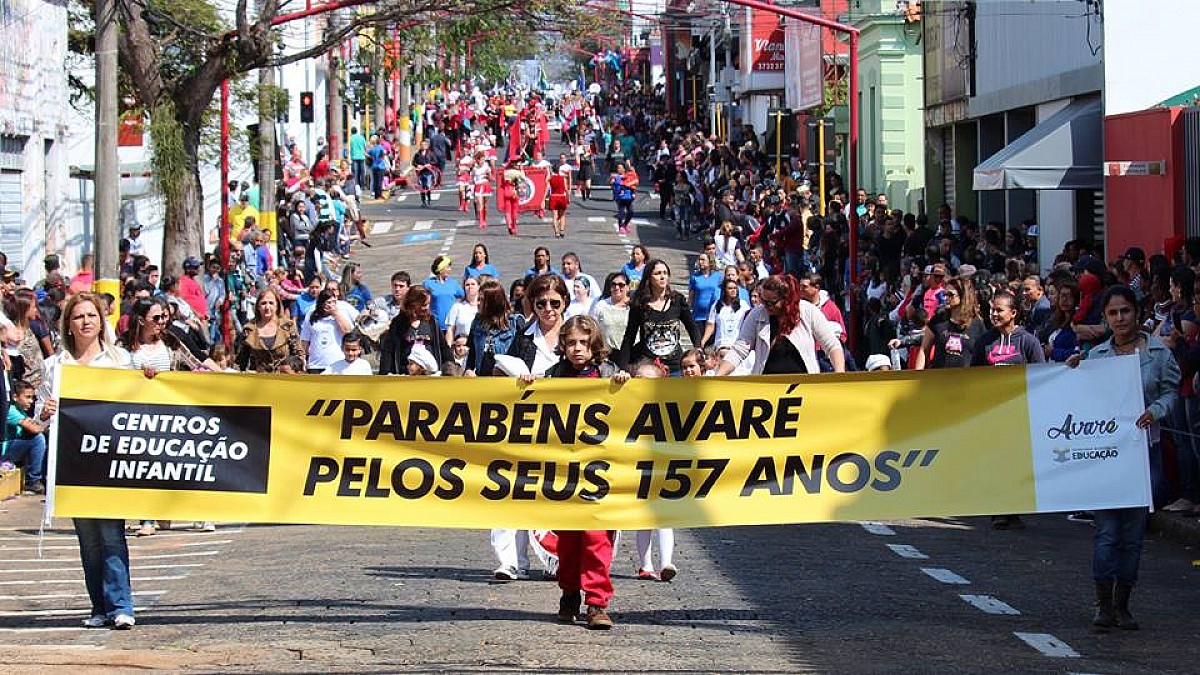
0, 152, 1200, 675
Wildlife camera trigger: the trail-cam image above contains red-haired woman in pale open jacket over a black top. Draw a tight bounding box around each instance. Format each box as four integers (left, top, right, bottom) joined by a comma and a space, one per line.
716, 275, 846, 375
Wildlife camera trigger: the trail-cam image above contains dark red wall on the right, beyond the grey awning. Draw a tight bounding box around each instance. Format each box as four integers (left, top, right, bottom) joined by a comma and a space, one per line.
1104, 108, 1186, 258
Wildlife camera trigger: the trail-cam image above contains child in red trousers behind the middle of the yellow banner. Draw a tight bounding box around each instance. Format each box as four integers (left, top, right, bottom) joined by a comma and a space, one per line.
521, 316, 629, 631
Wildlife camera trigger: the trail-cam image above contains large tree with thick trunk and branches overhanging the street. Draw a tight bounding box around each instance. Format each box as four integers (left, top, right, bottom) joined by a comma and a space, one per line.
72, 0, 574, 269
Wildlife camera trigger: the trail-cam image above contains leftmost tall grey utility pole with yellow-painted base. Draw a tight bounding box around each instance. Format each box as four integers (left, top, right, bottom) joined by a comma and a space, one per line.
92, 0, 121, 296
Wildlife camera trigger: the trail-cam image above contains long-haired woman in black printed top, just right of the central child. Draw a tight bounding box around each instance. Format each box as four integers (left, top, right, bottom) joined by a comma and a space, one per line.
616, 258, 700, 372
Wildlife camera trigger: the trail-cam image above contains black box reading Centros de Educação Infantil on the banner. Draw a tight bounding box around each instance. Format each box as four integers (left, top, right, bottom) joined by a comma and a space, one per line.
58, 399, 271, 494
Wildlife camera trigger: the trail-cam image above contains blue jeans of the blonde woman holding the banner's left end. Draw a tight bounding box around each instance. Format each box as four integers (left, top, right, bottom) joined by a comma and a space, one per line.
74, 518, 133, 619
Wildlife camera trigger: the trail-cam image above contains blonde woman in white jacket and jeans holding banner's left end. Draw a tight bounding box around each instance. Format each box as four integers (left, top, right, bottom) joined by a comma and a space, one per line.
41, 293, 147, 631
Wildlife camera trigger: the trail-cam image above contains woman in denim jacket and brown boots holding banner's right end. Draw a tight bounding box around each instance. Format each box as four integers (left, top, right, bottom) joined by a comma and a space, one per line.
1067, 286, 1180, 631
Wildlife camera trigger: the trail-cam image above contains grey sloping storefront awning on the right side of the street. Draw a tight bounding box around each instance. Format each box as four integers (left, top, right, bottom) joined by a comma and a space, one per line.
974, 98, 1104, 190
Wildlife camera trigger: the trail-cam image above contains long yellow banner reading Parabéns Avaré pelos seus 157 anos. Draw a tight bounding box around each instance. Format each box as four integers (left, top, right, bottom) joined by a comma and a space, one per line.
52, 358, 1148, 530
